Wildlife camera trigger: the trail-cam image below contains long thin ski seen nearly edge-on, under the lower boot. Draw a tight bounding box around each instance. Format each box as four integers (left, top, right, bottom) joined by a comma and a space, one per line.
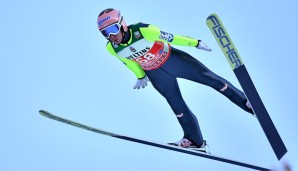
39, 110, 269, 170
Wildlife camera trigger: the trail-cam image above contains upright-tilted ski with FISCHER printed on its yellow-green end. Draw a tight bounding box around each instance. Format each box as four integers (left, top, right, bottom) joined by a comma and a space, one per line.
206, 14, 287, 160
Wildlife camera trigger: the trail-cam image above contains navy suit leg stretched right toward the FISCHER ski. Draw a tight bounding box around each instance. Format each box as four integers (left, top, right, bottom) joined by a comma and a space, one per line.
166, 48, 252, 113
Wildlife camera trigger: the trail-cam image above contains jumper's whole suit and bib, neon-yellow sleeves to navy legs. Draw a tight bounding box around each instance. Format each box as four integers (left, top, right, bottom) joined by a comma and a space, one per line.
106, 23, 251, 146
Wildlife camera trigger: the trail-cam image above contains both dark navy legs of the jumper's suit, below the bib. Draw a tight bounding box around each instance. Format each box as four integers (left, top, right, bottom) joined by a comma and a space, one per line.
145, 47, 251, 146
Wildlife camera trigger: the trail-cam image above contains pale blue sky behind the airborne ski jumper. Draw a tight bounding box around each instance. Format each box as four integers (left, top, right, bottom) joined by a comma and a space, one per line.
0, 0, 298, 171
